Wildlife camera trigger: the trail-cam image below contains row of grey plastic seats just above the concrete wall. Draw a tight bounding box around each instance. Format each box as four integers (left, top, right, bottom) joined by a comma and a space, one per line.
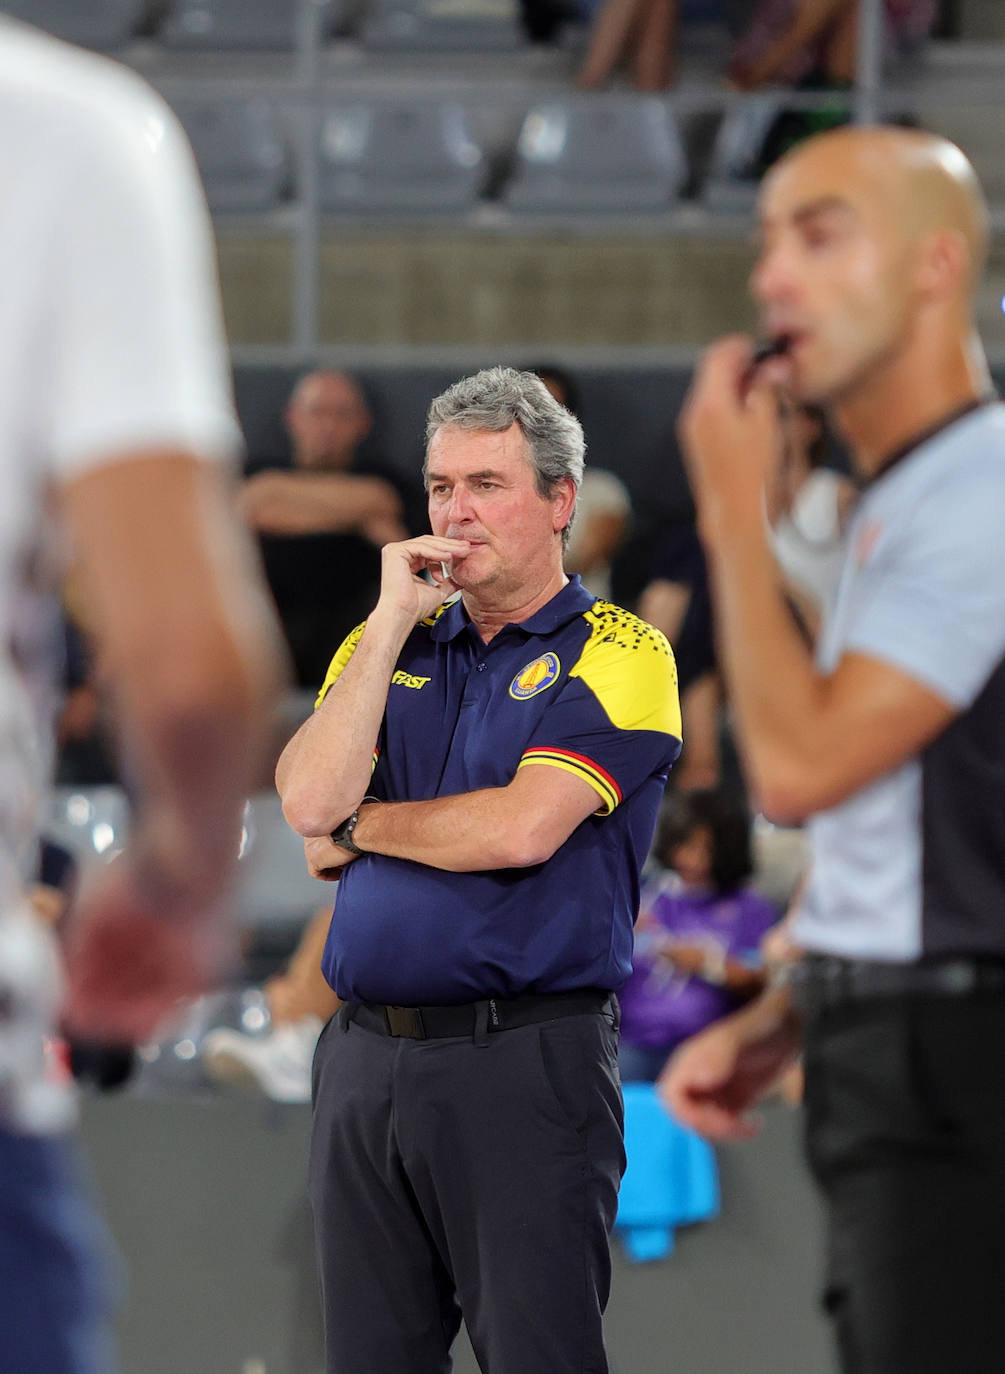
176, 95, 781, 216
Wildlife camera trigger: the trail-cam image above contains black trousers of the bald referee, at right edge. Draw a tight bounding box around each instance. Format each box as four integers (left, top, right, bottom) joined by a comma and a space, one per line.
806, 992, 1005, 1374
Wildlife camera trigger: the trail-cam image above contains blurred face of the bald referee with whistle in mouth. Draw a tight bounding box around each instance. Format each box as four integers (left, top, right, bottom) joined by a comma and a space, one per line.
751, 148, 914, 403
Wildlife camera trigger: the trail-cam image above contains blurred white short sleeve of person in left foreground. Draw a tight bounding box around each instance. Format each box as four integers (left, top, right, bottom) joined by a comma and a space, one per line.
40, 73, 241, 478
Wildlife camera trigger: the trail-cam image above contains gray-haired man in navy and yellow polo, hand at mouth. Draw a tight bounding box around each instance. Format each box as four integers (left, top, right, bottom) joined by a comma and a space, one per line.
278, 368, 681, 1374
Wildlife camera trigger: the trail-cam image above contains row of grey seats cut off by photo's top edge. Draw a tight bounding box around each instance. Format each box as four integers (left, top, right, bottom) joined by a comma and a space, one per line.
0, 0, 538, 52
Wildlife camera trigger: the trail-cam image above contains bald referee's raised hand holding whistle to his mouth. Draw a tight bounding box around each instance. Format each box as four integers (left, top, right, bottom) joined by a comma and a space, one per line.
678, 335, 788, 537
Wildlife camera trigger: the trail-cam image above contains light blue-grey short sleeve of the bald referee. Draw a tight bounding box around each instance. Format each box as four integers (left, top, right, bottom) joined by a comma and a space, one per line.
843, 460, 1005, 710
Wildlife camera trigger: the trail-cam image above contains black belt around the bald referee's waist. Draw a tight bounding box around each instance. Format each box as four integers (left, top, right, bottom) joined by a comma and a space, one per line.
792, 954, 1005, 1011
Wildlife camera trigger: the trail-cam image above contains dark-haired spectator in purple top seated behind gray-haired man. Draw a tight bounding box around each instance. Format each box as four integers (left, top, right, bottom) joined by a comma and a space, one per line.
619, 791, 778, 1083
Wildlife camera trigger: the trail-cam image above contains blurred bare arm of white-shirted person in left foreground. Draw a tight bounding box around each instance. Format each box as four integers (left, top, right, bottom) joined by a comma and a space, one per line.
62, 452, 285, 1039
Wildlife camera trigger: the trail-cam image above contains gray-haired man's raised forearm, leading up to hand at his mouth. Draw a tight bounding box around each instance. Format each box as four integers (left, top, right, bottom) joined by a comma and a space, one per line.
276, 613, 411, 835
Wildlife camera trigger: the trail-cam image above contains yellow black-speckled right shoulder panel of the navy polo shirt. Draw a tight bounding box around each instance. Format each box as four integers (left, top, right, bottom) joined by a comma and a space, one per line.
569, 602, 682, 739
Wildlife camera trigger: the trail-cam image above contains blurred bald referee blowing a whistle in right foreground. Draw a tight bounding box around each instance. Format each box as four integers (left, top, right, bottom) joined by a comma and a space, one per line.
661, 129, 1005, 1374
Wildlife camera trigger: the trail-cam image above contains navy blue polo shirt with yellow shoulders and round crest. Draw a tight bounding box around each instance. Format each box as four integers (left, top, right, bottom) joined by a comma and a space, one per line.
319, 577, 681, 1006
